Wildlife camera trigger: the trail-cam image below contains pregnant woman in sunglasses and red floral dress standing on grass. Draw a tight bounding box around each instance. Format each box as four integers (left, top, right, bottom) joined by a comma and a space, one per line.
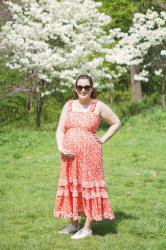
54, 75, 121, 239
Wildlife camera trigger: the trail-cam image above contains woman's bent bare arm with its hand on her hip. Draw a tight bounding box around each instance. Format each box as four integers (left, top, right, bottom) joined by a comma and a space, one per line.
99, 101, 121, 144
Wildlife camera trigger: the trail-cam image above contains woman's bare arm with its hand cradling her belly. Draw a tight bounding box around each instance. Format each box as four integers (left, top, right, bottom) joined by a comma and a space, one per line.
56, 103, 74, 157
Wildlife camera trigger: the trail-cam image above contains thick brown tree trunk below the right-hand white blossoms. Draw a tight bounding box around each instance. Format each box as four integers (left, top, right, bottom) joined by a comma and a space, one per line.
130, 65, 142, 102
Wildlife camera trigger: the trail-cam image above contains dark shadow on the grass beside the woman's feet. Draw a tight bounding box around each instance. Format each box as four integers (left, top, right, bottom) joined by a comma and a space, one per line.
80, 211, 138, 236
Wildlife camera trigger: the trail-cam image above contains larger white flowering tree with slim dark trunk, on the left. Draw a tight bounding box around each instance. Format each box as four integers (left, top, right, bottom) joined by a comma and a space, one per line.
1, 0, 115, 126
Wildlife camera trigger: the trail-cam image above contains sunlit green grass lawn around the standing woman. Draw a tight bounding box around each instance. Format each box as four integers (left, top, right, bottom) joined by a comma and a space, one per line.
0, 108, 166, 250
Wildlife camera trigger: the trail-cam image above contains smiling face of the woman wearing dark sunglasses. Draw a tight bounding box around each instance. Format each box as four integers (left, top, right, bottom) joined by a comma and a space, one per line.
75, 79, 93, 100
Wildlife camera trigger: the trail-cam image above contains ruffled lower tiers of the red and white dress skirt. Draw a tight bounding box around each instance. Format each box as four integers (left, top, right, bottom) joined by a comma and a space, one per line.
54, 180, 115, 221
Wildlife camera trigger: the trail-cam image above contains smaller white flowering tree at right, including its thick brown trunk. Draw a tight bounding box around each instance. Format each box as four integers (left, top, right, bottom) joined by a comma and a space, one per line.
106, 10, 166, 101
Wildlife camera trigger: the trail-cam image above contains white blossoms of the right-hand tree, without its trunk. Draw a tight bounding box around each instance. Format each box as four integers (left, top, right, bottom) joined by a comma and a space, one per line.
106, 10, 166, 81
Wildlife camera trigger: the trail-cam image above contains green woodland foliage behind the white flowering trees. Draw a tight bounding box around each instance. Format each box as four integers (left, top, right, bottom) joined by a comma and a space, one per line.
0, 0, 164, 126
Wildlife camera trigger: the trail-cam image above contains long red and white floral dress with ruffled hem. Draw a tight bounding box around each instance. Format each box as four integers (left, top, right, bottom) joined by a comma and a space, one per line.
54, 99, 115, 221
